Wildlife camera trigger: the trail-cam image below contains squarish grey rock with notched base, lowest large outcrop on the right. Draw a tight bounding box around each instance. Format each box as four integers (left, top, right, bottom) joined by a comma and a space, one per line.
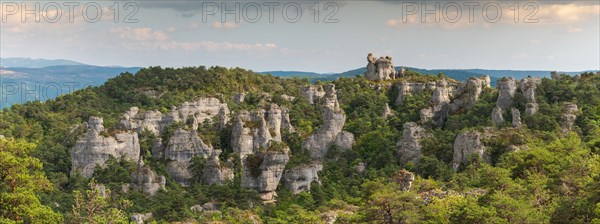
452, 131, 489, 170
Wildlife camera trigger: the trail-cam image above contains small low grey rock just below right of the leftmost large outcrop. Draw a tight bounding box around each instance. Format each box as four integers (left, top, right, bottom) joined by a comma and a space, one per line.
128, 166, 167, 195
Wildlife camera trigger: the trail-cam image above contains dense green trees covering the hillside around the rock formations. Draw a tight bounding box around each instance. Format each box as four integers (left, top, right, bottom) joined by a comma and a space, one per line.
0, 67, 600, 224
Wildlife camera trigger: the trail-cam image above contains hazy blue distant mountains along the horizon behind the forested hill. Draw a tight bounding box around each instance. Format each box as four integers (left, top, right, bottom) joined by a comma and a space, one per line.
0, 58, 596, 109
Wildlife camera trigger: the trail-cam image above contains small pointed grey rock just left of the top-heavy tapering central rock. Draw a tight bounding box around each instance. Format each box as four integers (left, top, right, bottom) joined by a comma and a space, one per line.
202, 150, 233, 185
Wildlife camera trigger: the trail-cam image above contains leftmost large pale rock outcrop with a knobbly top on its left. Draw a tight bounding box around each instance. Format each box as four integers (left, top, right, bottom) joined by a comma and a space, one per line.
71, 117, 140, 178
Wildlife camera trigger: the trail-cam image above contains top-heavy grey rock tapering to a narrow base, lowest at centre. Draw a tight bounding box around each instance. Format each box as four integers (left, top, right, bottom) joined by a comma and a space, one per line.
241, 147, 290, 202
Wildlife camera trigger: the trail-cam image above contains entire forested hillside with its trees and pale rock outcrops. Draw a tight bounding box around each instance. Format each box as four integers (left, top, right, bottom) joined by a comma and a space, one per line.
0, 67, 600, 223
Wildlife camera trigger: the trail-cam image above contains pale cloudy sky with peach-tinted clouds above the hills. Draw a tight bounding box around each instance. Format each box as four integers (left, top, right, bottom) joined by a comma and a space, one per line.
0, 0, 600, 73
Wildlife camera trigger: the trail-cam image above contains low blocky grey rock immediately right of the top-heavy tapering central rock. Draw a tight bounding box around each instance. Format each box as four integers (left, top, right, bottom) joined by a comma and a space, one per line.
283, 164, 323, 194
